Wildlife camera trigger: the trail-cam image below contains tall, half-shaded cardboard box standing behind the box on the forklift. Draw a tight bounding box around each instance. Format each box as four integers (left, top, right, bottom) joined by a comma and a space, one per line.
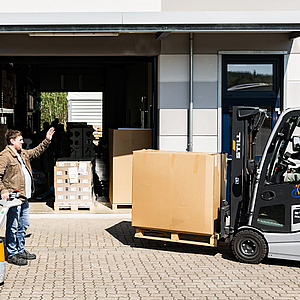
109, 129, 152, 206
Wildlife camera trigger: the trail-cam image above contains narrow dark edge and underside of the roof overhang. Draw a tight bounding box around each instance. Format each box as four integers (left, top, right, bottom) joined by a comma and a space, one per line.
0, 23, 300, 38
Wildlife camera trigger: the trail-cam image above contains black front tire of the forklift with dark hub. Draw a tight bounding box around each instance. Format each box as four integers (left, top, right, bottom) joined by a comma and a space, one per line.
230, 230, 268, 264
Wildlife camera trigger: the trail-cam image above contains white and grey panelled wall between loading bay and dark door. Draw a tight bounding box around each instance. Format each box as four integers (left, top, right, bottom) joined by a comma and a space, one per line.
158, 54, 218, 152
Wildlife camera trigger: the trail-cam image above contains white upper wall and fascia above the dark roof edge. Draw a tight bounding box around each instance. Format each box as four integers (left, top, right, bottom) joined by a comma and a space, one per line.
0, 0, 300, 25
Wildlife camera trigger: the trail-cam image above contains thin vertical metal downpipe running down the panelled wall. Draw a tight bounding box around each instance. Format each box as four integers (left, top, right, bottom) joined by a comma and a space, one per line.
187, 32, 194, 151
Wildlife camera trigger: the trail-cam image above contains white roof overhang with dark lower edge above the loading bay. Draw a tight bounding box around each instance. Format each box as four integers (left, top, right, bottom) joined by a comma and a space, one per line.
0, 10, 300, 38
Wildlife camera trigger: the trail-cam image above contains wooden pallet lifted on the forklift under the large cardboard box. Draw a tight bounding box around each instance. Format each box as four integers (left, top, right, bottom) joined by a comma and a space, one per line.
135, 228, 219, 247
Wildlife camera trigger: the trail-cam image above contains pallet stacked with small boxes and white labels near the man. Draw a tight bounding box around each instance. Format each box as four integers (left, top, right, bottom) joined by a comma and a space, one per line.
54, 158, 96, 211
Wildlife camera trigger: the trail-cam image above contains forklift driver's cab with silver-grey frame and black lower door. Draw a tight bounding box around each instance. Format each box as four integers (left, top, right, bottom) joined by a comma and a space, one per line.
251, 111, 300, 232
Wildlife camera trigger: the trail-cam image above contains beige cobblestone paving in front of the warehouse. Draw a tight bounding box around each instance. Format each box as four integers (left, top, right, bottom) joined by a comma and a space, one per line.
0, 214, 300, 300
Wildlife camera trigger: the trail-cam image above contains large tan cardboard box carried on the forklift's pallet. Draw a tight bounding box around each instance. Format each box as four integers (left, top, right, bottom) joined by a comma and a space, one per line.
132, 150, 226, 235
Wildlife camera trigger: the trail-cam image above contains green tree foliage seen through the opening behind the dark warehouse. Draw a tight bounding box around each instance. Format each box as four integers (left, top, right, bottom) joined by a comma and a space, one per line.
41, 93, 68, 129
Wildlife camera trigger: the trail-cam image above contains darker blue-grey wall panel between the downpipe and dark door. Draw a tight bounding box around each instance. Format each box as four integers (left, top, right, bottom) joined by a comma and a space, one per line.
194, 82, 218, 108
